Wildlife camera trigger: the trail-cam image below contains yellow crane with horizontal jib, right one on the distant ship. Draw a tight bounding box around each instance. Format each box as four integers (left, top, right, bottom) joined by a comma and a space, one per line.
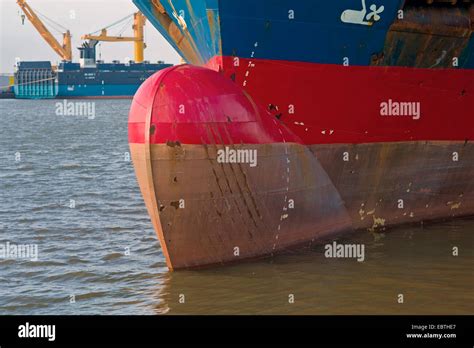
81, 12, 146, 63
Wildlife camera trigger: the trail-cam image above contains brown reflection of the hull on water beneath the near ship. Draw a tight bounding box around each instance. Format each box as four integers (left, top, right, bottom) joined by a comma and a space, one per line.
155, 219, 474, 315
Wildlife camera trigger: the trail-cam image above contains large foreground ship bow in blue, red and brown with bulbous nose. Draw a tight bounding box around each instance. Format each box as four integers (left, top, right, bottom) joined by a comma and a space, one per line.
129, 0, 474, 269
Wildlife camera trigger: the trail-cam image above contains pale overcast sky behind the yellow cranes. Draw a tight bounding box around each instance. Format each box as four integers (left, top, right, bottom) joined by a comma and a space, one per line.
0, 0, 180, 73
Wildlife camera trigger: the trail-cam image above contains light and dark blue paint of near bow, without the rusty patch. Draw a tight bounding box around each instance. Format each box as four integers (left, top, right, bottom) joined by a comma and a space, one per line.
134, 0, 403, 65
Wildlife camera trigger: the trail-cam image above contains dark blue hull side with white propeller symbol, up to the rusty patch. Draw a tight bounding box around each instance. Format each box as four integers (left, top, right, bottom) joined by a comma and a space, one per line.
219, 0, 401, 65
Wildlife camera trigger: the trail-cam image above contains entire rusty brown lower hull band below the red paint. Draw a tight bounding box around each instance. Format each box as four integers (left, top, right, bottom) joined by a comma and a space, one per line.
131, 142, 474, 269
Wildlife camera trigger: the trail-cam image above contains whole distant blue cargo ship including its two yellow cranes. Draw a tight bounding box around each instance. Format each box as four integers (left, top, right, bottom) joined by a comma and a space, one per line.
14, 0, 171, 99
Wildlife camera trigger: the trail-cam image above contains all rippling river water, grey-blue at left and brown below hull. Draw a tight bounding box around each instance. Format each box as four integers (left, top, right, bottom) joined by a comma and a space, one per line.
0, 100, 474, 314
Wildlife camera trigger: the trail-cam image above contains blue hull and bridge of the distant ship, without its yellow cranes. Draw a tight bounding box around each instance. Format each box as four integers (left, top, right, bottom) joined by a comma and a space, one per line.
15, 42, 172, 99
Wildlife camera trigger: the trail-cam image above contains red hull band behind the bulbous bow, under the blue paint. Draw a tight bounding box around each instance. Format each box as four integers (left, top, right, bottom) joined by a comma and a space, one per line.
212, 57, 474, 144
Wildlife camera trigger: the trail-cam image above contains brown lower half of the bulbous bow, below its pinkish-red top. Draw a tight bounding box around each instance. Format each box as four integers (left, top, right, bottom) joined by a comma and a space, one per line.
131, 144, 352, 269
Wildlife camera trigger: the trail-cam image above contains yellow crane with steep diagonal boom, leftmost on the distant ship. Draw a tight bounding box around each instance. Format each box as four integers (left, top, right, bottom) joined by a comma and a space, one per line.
16, 0, 72, 61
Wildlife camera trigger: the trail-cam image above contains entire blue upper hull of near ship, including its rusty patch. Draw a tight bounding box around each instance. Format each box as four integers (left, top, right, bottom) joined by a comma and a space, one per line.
133, 0, 474, 69
